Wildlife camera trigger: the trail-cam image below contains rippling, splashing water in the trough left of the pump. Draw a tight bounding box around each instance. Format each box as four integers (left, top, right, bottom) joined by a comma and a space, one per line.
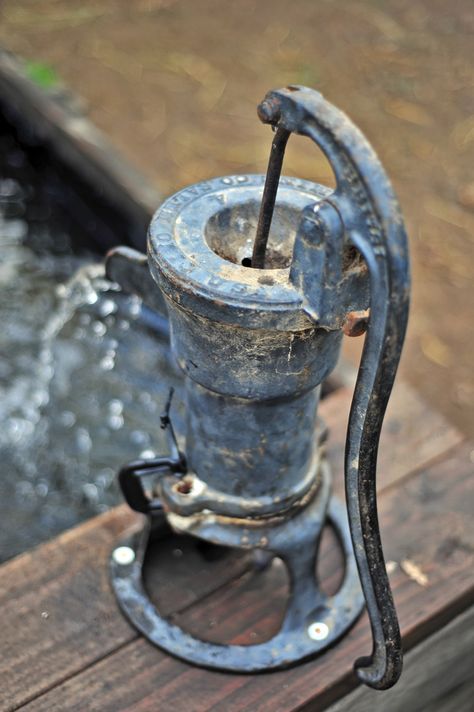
0, 138, 182, 560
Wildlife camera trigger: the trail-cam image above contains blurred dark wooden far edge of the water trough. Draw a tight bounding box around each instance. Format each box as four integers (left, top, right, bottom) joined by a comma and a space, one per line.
0, 48, 160, 249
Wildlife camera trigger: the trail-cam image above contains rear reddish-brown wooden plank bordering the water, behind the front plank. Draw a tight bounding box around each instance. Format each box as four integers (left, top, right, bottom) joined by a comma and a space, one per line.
0, 384, 461, 709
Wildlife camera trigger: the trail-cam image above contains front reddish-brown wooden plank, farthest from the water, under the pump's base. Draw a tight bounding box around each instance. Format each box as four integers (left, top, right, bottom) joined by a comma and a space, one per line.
18, 447, 474, 712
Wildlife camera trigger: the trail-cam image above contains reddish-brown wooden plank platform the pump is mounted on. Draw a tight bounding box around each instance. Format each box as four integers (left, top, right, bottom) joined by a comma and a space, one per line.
0, 385, 474, 712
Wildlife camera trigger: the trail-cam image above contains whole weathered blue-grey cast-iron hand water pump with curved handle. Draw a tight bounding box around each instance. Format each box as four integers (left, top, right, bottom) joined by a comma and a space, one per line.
108, 86, 409, 689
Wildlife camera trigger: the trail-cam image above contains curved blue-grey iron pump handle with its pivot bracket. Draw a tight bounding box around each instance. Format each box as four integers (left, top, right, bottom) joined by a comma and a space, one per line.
254, 86, 409, 689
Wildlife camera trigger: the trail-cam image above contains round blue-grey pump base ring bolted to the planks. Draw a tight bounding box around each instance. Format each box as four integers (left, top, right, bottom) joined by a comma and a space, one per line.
111, 497, 364, 673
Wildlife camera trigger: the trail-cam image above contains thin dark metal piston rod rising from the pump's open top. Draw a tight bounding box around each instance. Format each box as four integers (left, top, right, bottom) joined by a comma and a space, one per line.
252, 128, 290, 269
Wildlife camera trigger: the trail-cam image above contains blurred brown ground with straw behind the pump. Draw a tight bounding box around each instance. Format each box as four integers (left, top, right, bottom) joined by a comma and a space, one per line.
0, 0, 474, 434
